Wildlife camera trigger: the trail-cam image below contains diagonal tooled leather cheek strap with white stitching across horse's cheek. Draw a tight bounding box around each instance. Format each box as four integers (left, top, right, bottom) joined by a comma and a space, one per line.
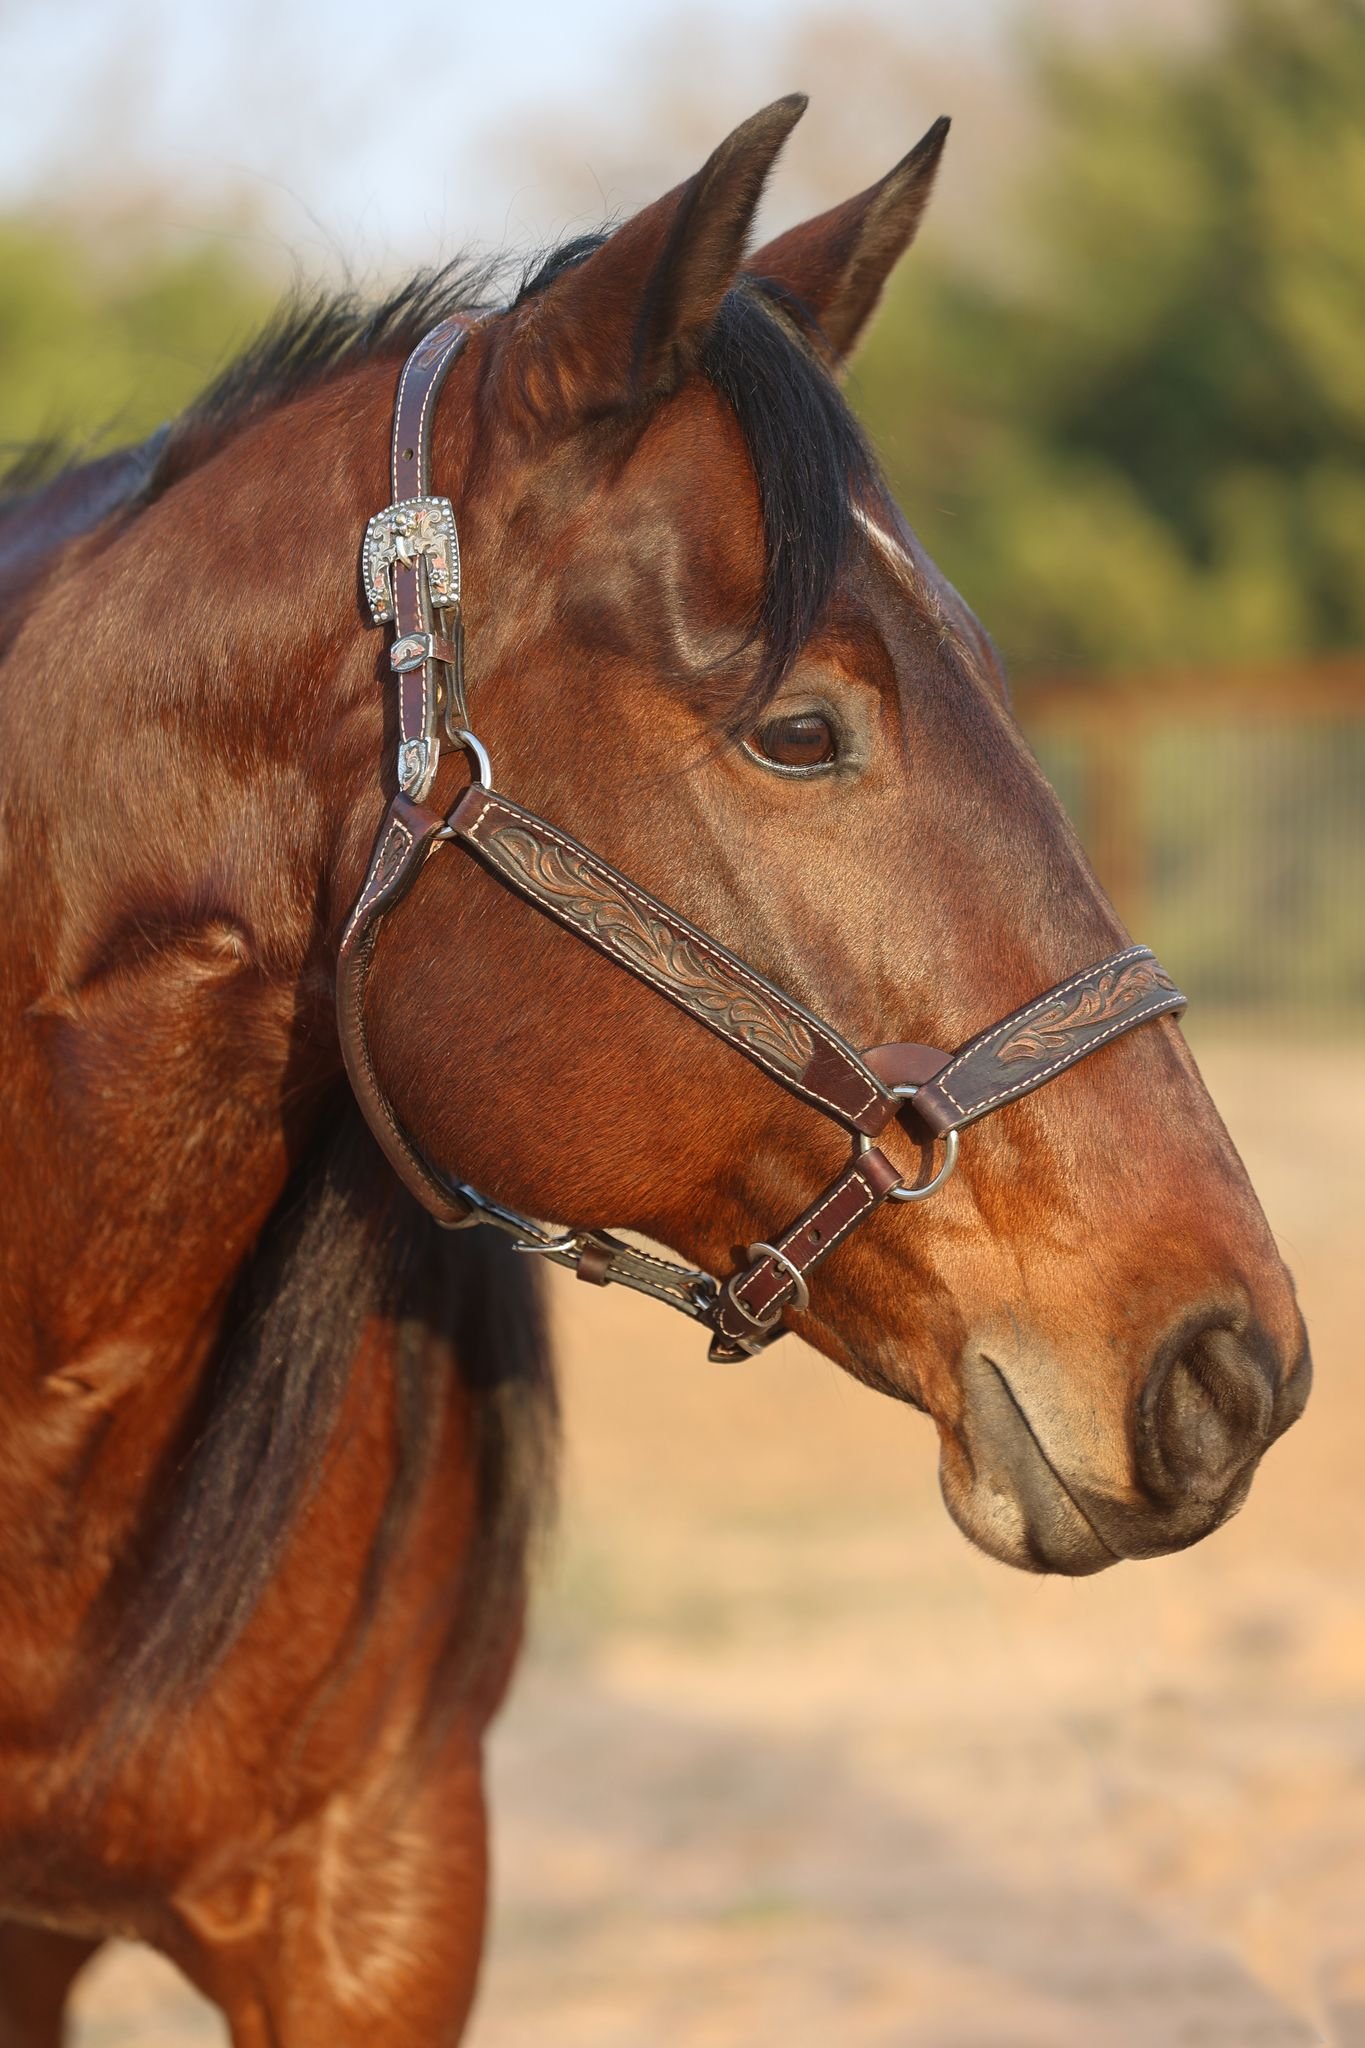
448, 782, 898, 1130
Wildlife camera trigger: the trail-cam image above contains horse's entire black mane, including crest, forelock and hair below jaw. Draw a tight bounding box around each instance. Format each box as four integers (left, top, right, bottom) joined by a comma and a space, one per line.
24, 236, 878, 1737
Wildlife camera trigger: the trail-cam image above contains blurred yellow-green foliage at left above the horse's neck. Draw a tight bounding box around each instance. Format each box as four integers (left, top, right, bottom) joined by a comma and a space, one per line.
0, 219, 274, 471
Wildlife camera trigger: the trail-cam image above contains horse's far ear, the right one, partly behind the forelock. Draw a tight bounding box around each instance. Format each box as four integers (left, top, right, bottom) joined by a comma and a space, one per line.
749, 115, 950, 356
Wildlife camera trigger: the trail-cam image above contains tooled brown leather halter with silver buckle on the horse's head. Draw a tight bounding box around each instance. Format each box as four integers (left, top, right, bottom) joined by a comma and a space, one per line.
338, 317, 1185, 1360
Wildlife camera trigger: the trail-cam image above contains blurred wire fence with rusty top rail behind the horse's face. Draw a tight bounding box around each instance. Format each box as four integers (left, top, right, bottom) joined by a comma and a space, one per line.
1017, 657, 1365, 1030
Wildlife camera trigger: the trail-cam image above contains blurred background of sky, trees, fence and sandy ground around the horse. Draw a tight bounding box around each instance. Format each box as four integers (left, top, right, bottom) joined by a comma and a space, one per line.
0, 0, 1365, 2048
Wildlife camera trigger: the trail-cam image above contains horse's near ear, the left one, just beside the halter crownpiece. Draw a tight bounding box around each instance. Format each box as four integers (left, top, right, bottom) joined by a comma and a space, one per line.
508, 92, 806, 426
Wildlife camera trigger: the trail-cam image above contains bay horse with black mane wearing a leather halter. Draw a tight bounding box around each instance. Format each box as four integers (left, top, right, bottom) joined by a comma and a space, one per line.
0, 98, 1310, 2048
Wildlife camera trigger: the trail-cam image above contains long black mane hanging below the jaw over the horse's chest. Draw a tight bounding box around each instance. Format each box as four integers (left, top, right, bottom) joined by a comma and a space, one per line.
96, 1098, 559, 1761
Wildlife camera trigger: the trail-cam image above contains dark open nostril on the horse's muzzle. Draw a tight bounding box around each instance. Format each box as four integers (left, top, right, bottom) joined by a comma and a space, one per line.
1136, 1317, 1275, 1501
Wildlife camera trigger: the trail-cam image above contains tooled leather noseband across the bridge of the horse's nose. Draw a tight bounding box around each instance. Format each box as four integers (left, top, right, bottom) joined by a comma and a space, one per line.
913, 946, 1185, 1135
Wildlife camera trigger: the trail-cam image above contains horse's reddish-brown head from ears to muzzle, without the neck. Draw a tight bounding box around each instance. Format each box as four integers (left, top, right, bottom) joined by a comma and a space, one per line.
336, 100, 1308, 1573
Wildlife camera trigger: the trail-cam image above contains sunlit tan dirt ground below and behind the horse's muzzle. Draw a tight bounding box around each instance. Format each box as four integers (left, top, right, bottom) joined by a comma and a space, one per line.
76, 1042, 1365, 2048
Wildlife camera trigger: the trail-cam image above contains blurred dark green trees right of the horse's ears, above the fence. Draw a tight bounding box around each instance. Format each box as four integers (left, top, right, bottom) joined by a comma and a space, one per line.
855, 0, 1365, 670
